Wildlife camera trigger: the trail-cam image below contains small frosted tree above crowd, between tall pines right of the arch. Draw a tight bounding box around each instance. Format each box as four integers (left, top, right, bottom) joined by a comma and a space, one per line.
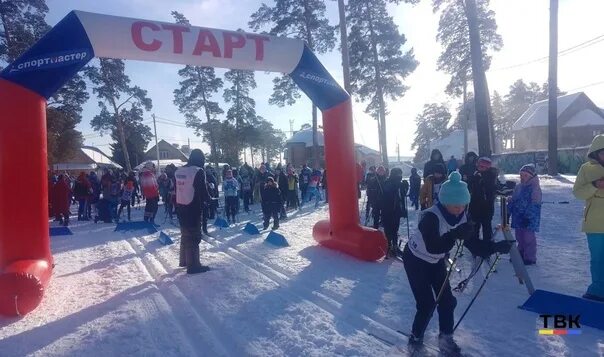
411, 103, 451, 163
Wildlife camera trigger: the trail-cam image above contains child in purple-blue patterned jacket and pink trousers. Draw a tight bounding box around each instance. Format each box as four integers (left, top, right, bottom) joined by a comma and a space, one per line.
508, 165, 541, 265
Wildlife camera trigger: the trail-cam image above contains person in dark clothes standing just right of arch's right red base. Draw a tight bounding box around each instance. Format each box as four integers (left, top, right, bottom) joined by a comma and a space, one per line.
378, 167, 409, 258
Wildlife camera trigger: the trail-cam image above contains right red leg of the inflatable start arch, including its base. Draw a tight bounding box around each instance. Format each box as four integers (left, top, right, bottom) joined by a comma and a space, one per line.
313, 100, 388, 261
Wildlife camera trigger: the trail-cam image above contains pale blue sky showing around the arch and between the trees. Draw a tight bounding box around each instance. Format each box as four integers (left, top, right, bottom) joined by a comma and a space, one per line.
47, 0, 604, 156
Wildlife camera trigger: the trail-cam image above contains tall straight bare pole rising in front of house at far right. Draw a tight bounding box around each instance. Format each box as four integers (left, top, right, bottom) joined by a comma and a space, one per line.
547, 0, 558, 176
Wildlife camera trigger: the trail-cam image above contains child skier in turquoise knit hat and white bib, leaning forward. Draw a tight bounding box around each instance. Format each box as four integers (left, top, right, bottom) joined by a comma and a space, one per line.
403, 171, 510, 354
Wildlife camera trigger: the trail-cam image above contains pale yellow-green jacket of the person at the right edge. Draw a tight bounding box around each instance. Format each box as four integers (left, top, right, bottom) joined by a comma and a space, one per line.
573, 135, 604, 233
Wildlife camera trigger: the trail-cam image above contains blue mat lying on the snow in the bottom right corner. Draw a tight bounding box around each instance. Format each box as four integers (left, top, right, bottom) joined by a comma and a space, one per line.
520, 290, 604, 330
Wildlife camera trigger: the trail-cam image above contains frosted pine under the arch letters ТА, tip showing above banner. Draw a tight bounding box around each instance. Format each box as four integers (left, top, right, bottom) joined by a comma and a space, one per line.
172, 11, 224, 166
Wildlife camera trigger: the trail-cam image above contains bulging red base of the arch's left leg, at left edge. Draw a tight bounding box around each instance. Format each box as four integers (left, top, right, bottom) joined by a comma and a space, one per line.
0, 260, 52, 317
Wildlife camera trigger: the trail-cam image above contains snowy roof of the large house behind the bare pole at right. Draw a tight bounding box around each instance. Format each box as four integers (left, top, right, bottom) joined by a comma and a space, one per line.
512, 92, 604, 131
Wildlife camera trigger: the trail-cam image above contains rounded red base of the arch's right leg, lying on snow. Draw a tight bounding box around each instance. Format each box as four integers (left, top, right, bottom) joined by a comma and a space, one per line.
312, 220, 388, 261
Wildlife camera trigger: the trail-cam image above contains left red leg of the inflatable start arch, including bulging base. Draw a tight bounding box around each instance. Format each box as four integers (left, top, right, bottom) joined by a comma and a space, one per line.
0, 79, 52, 316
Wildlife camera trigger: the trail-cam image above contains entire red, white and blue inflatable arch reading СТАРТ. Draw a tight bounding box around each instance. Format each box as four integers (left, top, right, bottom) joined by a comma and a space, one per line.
0, 11, 387, 316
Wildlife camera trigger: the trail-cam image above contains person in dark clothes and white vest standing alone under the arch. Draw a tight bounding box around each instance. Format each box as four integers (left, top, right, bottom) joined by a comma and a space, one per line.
175, 149, 210, 274
